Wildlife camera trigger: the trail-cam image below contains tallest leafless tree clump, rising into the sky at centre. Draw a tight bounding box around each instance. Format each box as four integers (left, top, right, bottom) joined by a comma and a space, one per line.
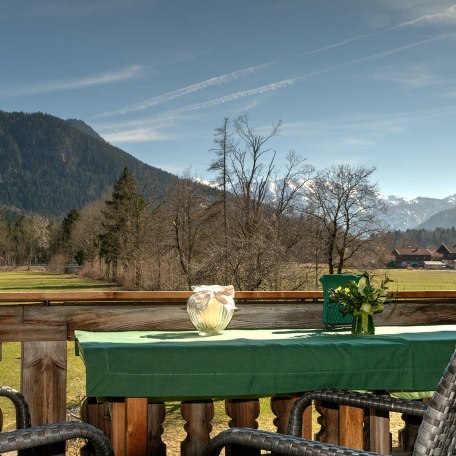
208, 116, 312, 290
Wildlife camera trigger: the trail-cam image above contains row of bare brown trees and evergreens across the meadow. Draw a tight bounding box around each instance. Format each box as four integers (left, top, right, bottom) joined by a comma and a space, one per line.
0, 116, 386, 290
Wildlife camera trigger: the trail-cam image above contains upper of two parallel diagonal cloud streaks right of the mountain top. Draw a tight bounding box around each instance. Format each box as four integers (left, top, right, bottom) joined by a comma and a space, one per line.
96, 63, 270, 117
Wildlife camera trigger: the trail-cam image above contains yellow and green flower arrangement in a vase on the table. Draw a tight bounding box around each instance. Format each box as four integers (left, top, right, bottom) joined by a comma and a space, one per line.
329, 272, 392, 333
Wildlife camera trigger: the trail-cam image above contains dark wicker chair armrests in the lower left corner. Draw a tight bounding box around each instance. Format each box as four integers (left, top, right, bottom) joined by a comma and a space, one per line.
0, 386, 114, 456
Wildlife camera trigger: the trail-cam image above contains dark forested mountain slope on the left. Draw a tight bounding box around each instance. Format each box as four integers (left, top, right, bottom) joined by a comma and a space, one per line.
0, 111, 177, 216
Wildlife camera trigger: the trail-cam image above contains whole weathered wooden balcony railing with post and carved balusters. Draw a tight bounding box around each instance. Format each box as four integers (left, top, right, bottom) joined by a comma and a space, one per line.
0, 290, 456, 455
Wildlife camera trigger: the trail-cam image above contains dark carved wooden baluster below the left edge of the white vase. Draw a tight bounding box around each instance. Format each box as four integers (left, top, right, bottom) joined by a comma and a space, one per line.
181, 400, 214, 456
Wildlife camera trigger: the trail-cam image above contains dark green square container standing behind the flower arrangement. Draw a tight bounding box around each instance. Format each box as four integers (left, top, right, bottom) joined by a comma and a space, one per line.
320, 274, 362, 326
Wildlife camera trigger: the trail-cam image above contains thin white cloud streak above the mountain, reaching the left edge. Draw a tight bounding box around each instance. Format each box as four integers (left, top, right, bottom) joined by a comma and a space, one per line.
2, 65, 142, 96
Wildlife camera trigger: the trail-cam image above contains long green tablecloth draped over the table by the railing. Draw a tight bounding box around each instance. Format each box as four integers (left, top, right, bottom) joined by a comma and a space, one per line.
75, 325, 456, 400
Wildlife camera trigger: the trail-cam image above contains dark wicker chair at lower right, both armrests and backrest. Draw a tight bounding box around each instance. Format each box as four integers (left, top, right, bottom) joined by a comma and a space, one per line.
203, 351, 456, 456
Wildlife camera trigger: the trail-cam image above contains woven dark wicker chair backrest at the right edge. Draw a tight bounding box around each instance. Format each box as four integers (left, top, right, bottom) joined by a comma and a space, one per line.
413, 351, 456, 456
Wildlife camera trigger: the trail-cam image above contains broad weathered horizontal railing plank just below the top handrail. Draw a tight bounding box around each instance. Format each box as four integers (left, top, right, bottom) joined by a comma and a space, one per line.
0, 292, 456, 341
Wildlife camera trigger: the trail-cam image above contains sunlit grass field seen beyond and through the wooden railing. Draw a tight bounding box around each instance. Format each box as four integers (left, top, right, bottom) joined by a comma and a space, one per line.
0, 270, 456, 454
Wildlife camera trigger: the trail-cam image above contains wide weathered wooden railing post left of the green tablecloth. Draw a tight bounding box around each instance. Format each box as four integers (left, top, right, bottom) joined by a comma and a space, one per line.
21, 341, 67, 456
